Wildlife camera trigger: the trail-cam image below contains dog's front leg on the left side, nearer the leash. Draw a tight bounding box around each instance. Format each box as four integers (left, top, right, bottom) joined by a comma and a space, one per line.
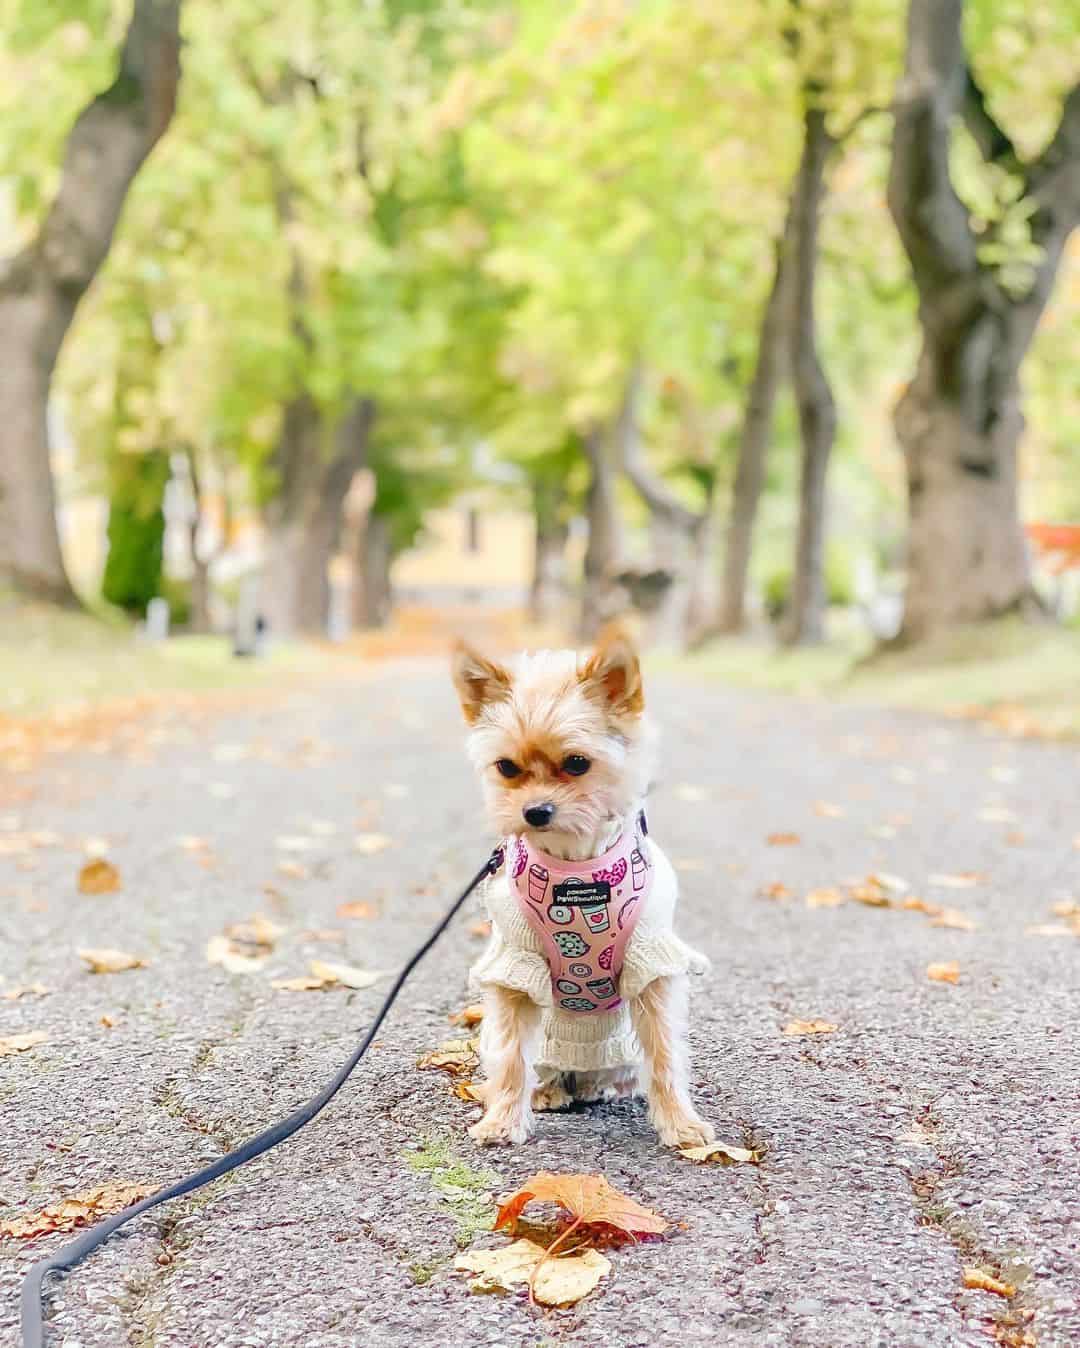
469, 984, 541, 1143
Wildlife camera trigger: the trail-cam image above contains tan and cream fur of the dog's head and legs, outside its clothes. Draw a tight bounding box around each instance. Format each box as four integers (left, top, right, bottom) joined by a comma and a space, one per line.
453, 630, 713, 1146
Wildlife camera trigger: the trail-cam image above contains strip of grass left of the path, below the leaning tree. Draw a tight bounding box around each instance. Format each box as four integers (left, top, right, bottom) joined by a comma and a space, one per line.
0, 596, 333, 717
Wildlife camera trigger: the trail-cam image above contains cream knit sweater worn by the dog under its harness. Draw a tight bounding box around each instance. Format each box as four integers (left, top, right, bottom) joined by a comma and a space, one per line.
469, 838, 709, 1072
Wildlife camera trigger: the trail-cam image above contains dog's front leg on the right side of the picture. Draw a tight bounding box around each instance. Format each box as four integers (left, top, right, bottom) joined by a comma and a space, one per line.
630, 975, 715, 1147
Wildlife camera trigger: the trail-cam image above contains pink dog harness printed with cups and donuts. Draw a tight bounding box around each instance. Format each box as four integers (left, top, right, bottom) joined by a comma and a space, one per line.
507, 814, 653, 1015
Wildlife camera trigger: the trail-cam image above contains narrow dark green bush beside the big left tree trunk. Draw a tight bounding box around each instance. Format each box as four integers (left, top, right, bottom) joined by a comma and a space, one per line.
101, 454, 169, 613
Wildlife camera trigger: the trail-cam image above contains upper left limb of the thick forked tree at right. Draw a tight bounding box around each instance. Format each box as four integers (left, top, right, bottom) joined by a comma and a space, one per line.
889, 0, 979, 295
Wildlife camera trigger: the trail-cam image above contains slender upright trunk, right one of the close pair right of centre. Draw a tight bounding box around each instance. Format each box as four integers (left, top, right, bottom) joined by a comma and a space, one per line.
783, 106, 836, 646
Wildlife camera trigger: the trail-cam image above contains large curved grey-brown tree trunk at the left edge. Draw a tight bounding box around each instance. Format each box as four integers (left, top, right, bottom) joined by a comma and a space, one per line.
0, 0, 179, 604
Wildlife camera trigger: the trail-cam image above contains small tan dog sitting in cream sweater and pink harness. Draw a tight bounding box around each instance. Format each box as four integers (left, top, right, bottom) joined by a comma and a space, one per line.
453, 628, 713, 1147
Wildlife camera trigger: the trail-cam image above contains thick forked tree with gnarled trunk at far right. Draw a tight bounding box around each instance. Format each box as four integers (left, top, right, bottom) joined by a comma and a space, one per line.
889, 0, 1080, 640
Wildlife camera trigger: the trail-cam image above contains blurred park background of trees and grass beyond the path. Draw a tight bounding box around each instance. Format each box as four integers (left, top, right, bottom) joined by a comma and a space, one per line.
0, 0, 1080, 732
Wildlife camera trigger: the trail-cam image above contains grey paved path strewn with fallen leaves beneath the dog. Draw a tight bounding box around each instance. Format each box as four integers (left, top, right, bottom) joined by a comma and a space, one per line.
0, 666, 1080, 1348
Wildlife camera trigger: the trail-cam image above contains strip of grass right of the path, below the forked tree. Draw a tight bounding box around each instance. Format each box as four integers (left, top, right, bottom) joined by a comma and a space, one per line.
677, 620, 1080, 736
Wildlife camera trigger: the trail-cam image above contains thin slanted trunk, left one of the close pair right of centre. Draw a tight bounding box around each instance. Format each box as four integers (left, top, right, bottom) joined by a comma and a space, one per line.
719, 208, 794, 632
